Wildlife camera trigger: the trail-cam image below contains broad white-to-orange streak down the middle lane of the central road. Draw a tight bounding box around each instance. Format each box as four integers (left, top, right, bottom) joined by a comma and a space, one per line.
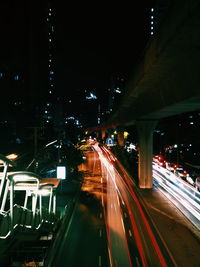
96, 147, 132, 267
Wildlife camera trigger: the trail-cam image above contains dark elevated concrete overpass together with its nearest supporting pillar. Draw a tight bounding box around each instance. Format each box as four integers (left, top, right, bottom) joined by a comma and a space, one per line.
99, 0, 200, 191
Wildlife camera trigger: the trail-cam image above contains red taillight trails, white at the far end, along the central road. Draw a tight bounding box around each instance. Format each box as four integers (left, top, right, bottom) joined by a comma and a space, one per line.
94, 146, 177, 267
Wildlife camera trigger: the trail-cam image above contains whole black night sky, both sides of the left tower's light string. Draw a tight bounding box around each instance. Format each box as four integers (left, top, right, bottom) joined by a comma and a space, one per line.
0, 0, 153, 107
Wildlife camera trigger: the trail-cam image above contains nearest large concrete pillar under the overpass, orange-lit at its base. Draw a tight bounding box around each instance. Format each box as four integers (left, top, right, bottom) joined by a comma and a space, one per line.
136, 120, 157, 188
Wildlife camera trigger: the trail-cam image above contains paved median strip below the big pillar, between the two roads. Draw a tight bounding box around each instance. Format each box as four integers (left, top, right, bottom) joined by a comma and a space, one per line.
138, 187, 200, 267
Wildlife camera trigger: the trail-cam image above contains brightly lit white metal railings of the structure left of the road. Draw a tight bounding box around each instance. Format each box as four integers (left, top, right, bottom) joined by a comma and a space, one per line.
0, 155, 56, 239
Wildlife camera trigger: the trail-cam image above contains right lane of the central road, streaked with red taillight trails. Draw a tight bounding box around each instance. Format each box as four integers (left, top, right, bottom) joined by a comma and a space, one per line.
95, 145, 176, 266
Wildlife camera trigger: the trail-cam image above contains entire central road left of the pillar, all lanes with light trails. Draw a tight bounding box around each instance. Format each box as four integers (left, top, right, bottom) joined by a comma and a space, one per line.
45, 144, 177, 267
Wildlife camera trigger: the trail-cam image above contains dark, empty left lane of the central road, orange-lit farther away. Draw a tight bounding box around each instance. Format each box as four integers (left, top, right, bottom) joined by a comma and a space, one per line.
45, 152, 110, 267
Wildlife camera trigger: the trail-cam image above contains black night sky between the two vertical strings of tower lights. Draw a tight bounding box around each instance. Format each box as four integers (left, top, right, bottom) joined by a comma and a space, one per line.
56, 1, 150, 99
